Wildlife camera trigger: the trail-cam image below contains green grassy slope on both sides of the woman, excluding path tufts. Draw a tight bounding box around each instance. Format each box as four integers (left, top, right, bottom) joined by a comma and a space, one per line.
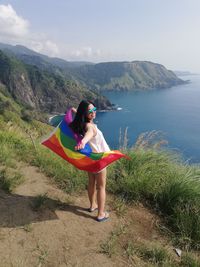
0, 93, 200, 266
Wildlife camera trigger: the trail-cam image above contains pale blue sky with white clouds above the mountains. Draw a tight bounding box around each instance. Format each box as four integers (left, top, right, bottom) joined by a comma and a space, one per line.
0, 0, 200, 73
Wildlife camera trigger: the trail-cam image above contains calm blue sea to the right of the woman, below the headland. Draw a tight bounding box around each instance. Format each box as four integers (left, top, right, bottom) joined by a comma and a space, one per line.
96, 75, 200, 163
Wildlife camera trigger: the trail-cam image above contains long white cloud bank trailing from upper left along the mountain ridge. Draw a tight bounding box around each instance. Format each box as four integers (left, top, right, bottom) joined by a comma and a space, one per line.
0, 4, 101, 60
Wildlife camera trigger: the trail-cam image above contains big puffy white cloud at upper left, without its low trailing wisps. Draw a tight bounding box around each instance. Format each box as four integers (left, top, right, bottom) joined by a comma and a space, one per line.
0, 4, 60, 56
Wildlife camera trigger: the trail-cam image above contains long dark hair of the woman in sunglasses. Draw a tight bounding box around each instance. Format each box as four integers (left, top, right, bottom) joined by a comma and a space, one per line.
69, 100, 93, 135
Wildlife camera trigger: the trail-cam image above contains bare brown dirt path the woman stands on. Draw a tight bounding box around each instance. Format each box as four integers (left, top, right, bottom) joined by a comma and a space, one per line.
0, 162, 190, 267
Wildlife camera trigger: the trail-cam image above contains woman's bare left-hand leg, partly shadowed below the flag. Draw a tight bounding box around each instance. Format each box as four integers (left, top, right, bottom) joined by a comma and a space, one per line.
88, 172, 97, 209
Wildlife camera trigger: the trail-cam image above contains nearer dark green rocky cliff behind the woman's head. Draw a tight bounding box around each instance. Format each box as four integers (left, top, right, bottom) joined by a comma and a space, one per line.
0, 50, 112, 113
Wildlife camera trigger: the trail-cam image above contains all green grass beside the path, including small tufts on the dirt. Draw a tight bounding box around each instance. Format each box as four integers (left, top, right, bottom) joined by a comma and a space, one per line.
0, 91, 200, 266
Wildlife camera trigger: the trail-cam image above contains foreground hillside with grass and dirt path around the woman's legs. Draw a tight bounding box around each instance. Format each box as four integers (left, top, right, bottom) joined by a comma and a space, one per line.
0, 101, 200, 267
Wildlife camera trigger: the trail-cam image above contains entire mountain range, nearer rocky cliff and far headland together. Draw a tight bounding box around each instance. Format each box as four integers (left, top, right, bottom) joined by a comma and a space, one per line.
0, 43, 188, 112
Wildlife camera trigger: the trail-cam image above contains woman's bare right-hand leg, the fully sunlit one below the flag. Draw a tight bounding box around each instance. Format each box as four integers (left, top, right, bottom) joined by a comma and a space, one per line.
95, 169, 107, 218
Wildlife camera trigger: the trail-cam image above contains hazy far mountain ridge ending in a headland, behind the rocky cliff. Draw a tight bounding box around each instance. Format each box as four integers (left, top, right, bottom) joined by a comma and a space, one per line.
0, 43, 186, 95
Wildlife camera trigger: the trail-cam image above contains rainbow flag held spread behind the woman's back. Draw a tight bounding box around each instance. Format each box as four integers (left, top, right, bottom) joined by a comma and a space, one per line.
42, 110, 128, 173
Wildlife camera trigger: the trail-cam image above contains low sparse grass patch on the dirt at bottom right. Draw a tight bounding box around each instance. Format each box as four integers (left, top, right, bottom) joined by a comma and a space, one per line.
100, 222, 179, 267
